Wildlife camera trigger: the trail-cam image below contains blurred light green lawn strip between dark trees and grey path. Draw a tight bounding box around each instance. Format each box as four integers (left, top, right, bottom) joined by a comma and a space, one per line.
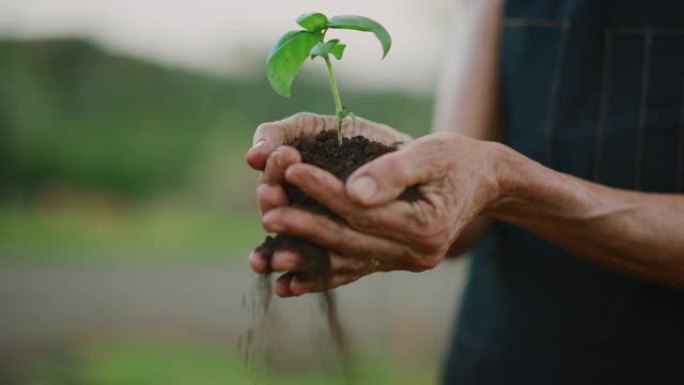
0, 203, 264, 258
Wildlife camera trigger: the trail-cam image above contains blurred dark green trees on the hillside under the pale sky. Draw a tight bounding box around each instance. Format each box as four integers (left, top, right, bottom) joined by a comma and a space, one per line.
0, 40, 431, 202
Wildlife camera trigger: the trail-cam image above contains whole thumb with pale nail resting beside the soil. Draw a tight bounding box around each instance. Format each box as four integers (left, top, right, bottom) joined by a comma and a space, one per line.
346, 137, 449, 206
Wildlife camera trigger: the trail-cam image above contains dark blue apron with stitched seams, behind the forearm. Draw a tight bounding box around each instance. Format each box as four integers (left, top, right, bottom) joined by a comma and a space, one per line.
444, 0, 684, 385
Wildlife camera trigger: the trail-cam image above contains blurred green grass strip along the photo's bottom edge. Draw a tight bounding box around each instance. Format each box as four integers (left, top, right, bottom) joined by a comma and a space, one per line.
13, 339, 436, 385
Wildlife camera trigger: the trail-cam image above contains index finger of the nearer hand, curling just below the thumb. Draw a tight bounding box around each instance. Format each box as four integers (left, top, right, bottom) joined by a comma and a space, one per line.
285, 164, 430, 241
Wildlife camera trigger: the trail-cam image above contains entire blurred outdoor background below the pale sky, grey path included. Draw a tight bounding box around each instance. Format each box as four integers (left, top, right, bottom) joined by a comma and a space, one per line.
0, 2, 470, 385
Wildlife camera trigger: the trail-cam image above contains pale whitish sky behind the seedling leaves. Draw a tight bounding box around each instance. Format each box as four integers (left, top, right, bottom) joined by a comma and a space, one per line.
0, 0, 457, 92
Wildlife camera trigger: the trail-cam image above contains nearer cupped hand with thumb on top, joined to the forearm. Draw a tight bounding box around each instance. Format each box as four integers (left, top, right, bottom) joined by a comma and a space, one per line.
252, 130, 508, 296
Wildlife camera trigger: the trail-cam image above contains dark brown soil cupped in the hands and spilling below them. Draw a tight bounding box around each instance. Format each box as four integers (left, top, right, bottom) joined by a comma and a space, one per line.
252, 130, 420, 380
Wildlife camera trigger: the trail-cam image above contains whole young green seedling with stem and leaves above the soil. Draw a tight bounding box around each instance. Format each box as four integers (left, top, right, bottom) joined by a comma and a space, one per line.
266, 12, 392, 145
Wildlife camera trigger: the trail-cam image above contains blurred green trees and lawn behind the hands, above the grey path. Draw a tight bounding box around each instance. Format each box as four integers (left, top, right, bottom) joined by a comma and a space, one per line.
0, 40, 431, 260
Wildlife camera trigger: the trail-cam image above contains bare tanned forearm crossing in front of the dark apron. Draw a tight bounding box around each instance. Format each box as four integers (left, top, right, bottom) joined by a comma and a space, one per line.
485, 149, 684, 288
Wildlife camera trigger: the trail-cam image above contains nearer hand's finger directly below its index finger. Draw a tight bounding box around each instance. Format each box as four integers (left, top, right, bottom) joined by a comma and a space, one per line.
261, 207, 409, 260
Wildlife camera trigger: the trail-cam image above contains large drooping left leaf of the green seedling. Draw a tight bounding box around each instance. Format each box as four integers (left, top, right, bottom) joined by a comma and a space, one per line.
266, 31, 321, 97
